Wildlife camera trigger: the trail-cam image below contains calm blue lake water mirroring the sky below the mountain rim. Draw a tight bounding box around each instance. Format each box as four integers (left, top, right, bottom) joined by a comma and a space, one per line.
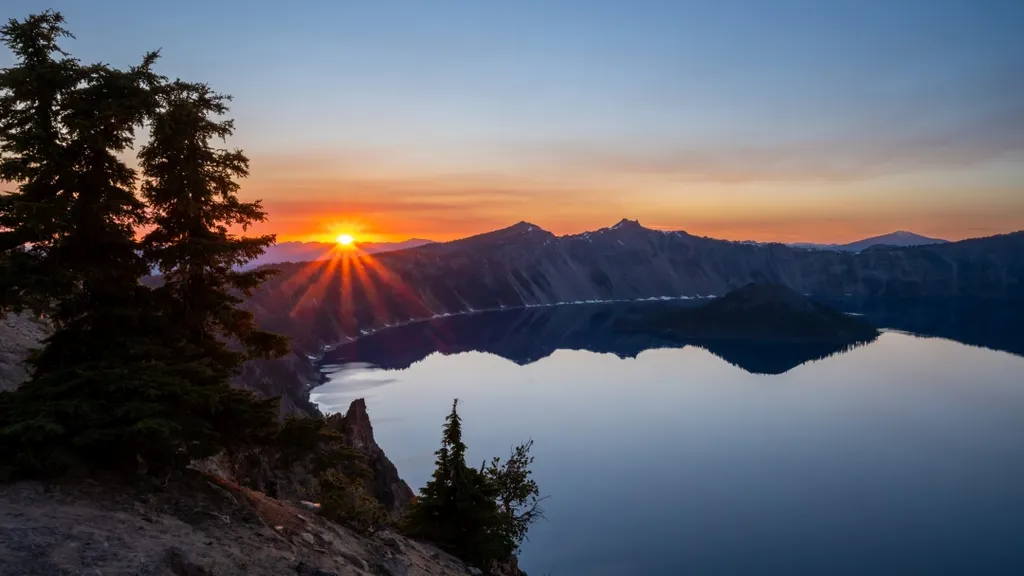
313, 303, 1024, 576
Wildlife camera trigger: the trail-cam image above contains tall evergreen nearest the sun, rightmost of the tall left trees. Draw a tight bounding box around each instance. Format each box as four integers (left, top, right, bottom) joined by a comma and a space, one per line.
139, 80, 288, 377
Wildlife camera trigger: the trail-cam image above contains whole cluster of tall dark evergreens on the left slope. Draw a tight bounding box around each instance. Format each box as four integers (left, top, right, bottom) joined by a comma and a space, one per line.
0, 12, 286, 476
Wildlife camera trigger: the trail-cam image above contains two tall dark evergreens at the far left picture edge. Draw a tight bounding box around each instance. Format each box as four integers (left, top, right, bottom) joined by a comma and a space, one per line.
0, 12, 188, 472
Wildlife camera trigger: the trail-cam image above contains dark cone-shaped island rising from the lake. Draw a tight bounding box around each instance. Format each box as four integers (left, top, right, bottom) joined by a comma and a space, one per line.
618, 284, 879, 343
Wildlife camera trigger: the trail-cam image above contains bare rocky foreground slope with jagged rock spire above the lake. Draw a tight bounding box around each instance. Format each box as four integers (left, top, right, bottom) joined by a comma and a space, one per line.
0, 400, 519, 576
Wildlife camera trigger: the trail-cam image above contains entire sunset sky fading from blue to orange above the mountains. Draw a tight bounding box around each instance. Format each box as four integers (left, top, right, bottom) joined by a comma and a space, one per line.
6, 0, 1024, 242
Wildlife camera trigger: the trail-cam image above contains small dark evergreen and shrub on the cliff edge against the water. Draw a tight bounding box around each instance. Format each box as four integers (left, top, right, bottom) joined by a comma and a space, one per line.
403, 400, 540, 567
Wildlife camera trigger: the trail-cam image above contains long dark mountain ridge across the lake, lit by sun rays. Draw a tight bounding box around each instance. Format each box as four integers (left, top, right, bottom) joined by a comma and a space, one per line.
249, 219, 1024, 354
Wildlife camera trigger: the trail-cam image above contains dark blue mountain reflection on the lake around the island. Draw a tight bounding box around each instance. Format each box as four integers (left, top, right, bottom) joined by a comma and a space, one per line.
324, 300, 1024, 374
